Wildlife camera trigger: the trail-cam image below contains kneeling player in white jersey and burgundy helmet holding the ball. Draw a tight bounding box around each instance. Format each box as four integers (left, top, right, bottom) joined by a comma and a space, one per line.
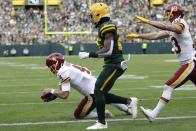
42, 53, 136, 119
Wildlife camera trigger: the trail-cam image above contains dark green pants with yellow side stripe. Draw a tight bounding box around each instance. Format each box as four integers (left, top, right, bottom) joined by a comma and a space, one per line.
94, 66, 128, 124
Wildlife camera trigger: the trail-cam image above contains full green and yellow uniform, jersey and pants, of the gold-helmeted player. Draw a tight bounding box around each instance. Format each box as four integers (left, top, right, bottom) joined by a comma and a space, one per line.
94, 18, 127, 123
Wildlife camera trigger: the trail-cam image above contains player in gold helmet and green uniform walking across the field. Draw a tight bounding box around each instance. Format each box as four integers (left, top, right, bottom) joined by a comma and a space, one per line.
79, 3, 137, 130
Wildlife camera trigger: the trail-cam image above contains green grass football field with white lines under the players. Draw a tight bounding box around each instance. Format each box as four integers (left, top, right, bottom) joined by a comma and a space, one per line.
0, 55, 196, 131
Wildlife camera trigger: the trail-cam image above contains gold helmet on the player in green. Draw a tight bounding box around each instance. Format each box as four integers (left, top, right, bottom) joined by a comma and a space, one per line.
89, 3, 110, 24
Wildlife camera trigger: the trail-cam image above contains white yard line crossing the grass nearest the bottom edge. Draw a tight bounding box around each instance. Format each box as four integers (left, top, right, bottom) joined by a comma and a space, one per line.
0, 116, 196, 127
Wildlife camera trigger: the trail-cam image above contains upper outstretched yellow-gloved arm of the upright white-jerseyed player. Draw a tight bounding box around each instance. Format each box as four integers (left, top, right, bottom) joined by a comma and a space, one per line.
135, 16, 184, 33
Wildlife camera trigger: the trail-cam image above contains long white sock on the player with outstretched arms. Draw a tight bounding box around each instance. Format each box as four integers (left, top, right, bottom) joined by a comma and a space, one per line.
152, 85, 174, 117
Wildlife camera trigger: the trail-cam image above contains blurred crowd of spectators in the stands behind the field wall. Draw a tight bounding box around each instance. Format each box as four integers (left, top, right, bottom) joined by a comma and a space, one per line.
0, 0, 196, 45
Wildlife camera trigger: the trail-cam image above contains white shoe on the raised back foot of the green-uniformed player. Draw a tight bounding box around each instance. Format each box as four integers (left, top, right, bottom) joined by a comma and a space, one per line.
128, 97, 138, 119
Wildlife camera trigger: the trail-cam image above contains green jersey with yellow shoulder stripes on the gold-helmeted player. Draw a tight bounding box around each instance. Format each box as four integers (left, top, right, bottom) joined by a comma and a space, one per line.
96, 21, 124, 64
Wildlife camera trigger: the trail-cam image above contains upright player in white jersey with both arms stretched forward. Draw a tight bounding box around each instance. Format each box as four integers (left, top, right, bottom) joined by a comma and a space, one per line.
127, 4, 196, 122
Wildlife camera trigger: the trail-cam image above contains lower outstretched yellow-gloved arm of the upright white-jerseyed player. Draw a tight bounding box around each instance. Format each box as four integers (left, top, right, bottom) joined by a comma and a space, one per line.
126, 31, 169, 40
